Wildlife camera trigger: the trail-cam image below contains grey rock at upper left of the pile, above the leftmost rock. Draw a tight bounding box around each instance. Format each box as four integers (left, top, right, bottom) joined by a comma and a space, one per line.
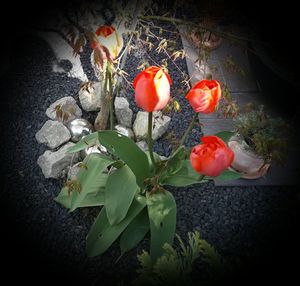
46, 96, 82, 123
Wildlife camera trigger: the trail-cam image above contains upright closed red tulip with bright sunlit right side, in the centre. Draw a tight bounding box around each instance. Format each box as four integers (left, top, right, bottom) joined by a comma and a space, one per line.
133, 66, 172, 112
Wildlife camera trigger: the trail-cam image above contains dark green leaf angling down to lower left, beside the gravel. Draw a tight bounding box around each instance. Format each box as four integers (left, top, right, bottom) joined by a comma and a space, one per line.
86, 196, 146, 257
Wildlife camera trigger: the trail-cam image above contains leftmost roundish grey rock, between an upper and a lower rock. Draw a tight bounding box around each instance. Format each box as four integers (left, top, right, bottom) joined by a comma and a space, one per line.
35, 120, 71, 149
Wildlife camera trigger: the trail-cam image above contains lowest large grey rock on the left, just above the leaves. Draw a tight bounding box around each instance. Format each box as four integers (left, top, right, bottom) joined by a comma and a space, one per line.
37, 142, 79, 178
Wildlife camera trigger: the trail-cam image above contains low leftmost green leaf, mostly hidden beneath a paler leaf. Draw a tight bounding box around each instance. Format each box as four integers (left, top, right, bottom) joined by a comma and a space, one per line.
54, 188, 104, 209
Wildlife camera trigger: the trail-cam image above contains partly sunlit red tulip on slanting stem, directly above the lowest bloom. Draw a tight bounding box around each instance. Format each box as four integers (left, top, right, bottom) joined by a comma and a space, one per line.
185, 79, 221, 113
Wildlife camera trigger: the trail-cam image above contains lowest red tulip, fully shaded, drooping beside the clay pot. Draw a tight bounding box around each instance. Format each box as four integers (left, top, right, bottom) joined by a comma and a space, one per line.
190, 136, 234, 177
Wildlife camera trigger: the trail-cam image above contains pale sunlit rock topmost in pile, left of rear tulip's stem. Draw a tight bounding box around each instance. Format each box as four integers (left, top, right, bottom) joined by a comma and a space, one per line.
79, 82, 103, 111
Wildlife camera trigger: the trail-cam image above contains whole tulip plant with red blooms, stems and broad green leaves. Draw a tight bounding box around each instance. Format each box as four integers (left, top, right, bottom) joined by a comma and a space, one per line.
56, 27, 239, 263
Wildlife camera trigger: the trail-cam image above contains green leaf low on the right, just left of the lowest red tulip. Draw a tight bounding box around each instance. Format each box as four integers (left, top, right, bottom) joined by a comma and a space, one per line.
161, 160, 206, 187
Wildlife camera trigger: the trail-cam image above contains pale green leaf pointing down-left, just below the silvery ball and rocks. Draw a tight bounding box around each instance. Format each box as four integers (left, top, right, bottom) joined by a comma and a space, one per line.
70, 153, 112, 212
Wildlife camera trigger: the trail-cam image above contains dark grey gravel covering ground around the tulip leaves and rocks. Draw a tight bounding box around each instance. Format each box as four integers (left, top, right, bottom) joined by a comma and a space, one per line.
0, 16, 299, 285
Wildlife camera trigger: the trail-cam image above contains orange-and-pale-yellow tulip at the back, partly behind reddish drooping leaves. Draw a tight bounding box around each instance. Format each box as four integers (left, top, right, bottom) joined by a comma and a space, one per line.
91, 26, 124, 59
